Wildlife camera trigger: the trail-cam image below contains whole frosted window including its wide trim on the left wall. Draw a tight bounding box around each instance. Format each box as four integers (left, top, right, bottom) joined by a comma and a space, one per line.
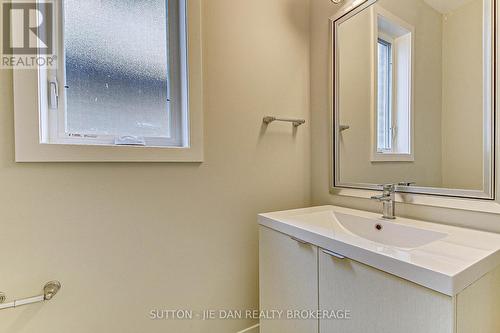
13, 0, 203, 162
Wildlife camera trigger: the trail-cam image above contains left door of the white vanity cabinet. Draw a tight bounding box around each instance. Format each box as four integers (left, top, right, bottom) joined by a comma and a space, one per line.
259, 227, 318, 333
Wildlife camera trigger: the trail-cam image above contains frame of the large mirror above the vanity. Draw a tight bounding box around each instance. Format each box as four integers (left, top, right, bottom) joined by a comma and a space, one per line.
329, 0, 500, 214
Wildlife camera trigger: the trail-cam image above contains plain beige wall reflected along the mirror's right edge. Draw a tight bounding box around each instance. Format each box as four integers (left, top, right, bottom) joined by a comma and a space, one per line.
441, 0, 484, 190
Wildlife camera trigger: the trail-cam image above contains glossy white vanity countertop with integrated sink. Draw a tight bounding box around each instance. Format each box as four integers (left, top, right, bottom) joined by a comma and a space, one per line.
259, 206, 500, 296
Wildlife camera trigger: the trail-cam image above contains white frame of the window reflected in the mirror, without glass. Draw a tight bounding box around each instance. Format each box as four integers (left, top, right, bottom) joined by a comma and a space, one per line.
371, 5, 415, 162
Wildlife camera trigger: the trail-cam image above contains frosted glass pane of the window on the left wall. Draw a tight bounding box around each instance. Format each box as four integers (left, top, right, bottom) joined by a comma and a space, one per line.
63, 0, 171, 138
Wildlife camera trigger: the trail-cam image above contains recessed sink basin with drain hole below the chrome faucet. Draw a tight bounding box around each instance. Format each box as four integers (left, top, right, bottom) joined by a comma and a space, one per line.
333, 212, 447, 248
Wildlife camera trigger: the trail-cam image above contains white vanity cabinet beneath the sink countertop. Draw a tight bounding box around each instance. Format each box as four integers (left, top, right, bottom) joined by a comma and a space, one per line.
260, 226, 500, 333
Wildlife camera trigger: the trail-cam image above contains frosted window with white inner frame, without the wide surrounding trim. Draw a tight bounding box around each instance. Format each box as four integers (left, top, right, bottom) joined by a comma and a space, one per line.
42, 0, 189, 147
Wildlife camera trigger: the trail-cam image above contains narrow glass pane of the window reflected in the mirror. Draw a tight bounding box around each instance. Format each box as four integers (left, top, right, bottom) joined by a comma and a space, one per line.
377, 40, 392, 151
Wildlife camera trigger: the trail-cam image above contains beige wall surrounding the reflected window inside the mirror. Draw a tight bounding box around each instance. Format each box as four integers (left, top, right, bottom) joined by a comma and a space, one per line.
339, 0, 442, 187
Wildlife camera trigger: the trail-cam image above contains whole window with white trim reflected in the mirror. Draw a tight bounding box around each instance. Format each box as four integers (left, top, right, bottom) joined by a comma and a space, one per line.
372, 6, 414, 162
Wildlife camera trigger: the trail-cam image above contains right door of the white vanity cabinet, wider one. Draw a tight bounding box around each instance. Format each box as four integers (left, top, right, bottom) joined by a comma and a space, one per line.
319, 250, 454, 333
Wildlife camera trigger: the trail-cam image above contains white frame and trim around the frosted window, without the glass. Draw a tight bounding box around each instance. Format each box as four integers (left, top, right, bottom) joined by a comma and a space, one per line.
14, 0, 203, 162
